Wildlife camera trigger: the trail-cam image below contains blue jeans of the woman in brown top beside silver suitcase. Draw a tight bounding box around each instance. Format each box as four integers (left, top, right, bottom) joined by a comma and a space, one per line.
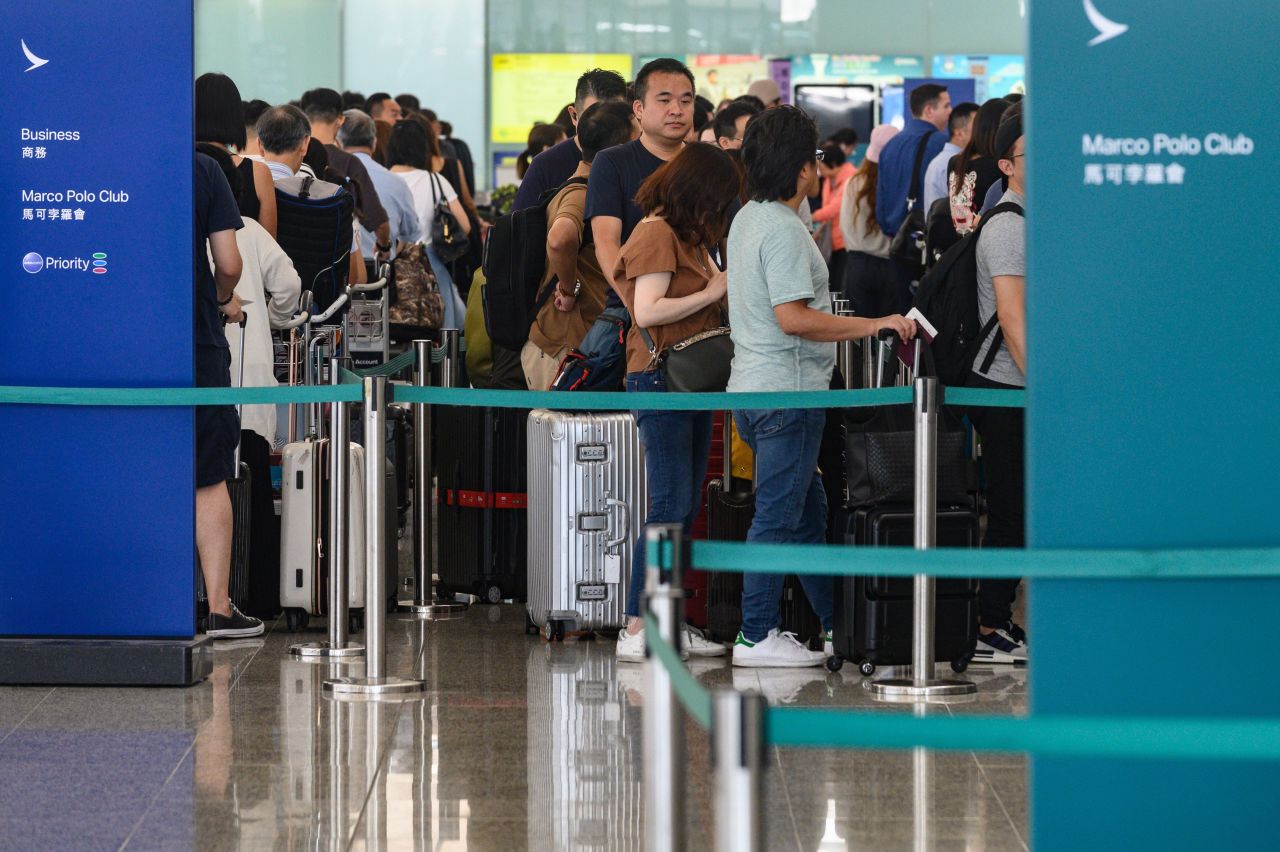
626, 371, 712, 615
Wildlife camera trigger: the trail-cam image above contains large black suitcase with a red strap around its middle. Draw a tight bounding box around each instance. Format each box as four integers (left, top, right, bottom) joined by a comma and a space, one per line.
431, 406, 529, 604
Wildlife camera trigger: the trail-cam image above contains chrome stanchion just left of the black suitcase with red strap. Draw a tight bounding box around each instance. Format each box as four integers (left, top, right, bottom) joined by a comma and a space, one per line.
399, 340, 466, 618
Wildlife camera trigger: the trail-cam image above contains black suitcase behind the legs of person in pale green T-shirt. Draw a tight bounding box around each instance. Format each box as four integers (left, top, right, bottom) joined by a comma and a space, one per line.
707, 412, 822, 642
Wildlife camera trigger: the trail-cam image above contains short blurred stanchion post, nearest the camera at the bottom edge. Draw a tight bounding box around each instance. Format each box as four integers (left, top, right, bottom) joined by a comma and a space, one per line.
712, 690, 767, 852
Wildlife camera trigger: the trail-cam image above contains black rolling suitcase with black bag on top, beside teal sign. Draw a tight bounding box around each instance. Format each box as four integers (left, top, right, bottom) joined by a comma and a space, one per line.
828, 332, 978, 677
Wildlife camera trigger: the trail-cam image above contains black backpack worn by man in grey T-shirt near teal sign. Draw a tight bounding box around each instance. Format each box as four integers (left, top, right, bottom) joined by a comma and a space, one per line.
915, 202, 1025, 386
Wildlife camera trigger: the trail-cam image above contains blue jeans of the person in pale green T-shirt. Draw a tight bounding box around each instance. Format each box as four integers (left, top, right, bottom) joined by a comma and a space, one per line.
733, 408, 832, 642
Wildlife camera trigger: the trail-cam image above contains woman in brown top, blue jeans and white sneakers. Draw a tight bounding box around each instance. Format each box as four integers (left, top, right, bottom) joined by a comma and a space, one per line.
613, 142, 741, 649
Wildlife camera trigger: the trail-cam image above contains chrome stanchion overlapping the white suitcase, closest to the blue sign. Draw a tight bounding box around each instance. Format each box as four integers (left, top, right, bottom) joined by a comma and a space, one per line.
289, 358, 365, 660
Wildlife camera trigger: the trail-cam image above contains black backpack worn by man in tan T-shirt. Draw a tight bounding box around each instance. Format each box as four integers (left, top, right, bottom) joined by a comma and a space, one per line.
484, 178, 586, 351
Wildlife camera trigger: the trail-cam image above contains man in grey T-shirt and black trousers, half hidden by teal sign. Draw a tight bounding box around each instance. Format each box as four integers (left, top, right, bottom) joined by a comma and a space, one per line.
968, 97, 1027, 663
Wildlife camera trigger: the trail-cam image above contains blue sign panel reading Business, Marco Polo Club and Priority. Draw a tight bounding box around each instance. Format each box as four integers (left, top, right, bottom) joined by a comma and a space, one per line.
0, 0, 195, 638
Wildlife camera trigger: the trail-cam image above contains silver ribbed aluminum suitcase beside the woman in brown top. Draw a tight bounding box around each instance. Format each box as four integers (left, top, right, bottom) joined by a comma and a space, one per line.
527, 409, 648, 638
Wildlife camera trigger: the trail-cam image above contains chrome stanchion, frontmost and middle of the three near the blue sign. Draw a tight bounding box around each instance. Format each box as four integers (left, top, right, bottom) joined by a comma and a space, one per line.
324, 376, 426, 697
